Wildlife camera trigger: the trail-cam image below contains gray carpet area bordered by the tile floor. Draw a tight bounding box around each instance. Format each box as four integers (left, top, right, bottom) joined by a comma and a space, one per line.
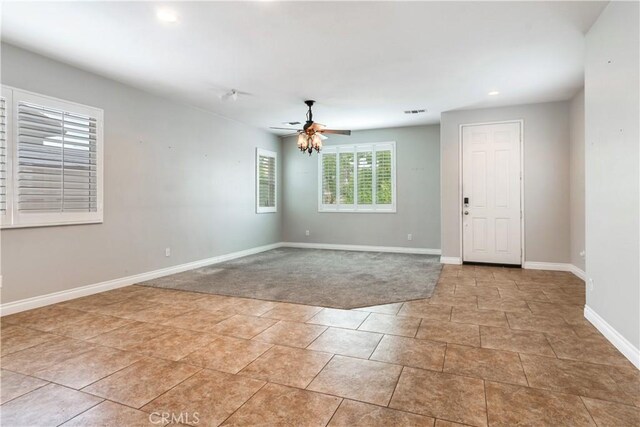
140, 248, 442, 308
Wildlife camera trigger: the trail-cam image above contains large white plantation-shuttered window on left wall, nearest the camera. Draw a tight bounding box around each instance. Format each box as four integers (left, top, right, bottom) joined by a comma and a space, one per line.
0, 85, 103, 227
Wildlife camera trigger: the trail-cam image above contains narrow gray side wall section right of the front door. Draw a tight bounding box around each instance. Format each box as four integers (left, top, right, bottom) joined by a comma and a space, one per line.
569, 90, 585, 271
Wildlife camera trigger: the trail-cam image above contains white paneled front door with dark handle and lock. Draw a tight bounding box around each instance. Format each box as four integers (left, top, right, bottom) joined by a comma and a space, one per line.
462, 122, 522, 264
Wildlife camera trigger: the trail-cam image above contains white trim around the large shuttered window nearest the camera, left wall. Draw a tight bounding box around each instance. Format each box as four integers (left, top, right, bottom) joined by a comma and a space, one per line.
0, 85, 104, 229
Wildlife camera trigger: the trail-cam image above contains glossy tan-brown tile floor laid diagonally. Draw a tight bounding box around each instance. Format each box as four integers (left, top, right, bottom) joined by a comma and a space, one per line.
0, 266, 640, 427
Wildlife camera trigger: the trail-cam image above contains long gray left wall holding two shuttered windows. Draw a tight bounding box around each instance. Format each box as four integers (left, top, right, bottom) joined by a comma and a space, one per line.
2, 44, 281, 303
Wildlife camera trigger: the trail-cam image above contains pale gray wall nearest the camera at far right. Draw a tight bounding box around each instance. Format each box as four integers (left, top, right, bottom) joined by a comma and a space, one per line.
585, 2, 640, 349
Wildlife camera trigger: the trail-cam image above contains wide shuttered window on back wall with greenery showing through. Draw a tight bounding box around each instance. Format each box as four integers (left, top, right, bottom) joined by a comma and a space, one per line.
318, 142, 396, 212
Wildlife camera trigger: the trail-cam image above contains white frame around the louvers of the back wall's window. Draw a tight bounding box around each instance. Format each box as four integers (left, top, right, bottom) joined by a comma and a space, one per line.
318, 141, 397, 213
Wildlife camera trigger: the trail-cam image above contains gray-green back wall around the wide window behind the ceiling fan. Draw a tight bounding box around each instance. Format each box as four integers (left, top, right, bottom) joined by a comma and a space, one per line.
282, 125, 440, 249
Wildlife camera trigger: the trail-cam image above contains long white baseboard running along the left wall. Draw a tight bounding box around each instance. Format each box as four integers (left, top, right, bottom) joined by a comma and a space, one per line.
0, 243, 282, 316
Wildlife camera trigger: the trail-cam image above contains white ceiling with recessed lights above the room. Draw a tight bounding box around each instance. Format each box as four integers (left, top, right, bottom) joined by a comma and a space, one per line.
2, 1, 606, 134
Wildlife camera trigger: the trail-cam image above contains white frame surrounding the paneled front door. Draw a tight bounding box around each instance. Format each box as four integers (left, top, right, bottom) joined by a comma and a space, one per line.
457, 119, 525, 268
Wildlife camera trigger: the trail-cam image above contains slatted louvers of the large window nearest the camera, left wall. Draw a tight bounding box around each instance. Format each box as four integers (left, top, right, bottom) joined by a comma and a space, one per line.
16, 101, 98, 213
